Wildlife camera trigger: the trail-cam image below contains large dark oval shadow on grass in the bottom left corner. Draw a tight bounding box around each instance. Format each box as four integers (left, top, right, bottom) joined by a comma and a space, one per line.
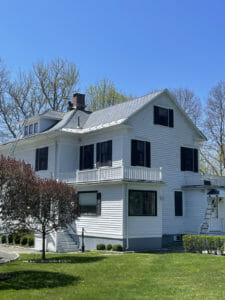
0, 271, 80, 291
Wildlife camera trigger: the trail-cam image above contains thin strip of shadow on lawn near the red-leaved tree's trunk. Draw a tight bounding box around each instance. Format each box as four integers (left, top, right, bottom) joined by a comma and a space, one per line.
47, 254, 106, 264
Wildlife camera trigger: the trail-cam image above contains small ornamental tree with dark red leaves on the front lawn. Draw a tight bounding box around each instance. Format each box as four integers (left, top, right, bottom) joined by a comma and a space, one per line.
0, 156, 79, 259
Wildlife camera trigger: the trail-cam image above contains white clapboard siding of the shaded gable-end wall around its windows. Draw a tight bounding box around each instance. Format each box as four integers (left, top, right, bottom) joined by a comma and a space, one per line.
124, 95, 203, 234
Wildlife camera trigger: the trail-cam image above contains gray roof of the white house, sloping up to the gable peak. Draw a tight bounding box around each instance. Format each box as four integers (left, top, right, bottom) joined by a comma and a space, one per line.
0, 90, 206, 148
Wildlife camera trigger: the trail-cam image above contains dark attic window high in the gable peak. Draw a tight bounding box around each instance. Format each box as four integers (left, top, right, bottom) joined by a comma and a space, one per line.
154, 106, 174, 127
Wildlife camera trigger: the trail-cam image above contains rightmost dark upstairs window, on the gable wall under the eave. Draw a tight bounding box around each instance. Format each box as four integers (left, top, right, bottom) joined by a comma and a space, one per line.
180, 147, 198, 173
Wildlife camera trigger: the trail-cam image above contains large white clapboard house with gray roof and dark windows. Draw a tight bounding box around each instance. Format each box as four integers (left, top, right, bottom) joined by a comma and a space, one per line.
0, 90, 225, 251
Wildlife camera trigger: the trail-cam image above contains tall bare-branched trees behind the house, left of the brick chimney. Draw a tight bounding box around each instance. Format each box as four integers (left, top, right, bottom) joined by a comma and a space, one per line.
0, 59, 79, 138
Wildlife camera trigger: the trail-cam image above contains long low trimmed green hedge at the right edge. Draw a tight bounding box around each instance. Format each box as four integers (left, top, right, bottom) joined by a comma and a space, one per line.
183, 234, 225, 253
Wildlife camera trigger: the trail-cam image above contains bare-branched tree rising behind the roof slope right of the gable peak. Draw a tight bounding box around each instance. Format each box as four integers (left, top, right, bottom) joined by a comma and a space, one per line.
170, 88, 202, 125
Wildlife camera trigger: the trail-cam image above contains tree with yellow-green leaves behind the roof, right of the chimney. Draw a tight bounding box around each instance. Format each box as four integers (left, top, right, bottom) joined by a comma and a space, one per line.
86, 78, 130, 111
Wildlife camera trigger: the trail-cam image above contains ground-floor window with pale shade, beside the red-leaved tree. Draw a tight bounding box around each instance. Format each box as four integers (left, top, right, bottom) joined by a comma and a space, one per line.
78, 191, 101, 216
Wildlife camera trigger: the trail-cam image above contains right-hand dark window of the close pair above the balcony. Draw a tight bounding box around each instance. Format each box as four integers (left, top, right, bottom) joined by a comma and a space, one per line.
96, 141, 112, 168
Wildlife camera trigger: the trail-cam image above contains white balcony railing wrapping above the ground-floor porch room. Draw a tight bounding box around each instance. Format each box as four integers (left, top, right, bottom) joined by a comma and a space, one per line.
38, 166, 162, 184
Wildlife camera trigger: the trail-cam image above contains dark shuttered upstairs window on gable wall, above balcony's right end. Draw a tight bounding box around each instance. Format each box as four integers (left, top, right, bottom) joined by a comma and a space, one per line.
131, 140, 151, 168
